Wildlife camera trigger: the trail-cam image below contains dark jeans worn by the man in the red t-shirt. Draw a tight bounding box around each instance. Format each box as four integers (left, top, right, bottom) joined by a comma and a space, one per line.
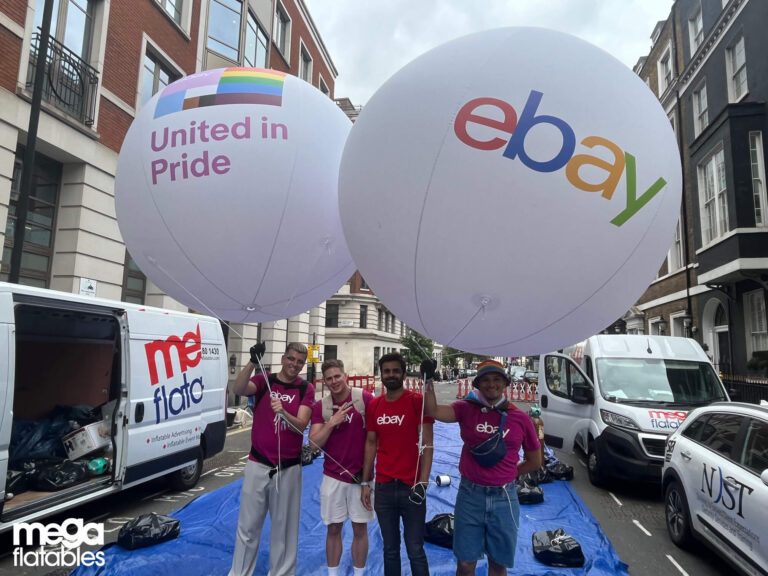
373, 480, 429, 576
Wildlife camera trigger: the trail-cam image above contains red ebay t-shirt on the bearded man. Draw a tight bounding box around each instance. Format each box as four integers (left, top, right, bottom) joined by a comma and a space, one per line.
365, 390, 435, 486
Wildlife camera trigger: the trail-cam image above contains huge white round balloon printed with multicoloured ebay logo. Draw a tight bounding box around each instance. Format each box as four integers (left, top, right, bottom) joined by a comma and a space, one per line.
339, 28, 682, 355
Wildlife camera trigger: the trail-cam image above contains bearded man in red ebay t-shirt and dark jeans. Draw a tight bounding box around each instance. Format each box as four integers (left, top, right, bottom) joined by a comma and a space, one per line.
361, 352, 434, 576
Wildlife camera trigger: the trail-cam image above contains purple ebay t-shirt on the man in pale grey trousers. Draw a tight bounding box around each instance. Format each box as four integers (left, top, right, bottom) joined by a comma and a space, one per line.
250, 374, 315, 464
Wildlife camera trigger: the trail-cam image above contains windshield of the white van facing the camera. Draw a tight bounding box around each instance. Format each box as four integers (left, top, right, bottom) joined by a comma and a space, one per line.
596, 358, 726, 405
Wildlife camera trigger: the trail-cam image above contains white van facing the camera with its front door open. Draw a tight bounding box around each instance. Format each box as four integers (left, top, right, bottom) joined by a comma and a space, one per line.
538, 334, 729, 485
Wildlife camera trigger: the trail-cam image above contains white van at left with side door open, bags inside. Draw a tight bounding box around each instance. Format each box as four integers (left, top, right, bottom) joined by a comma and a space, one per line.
0, 283, 227, 532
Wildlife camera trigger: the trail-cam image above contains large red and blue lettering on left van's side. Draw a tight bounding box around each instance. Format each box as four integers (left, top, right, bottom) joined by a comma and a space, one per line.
144, 324, 205, 423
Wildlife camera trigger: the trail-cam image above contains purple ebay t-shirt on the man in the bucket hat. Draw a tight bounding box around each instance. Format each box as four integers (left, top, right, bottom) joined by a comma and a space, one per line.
451, 400, 541, 486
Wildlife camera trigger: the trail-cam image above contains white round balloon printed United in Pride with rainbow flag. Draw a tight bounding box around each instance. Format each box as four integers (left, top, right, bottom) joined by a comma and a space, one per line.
115, 68, 355, 322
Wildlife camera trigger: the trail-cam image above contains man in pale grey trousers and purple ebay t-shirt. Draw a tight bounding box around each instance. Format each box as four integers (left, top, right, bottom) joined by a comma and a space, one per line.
229, 342, 315, 576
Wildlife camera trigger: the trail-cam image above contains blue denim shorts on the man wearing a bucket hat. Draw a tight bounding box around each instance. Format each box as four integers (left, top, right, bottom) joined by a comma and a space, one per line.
453, 478, 520, 568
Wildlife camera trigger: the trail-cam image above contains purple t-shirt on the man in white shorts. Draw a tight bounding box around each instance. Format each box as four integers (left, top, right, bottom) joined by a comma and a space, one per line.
312, 390, 373, 483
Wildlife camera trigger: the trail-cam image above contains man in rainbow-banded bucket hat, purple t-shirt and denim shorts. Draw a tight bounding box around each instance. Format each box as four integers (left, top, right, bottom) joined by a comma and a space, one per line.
421, 359, 541, 576
